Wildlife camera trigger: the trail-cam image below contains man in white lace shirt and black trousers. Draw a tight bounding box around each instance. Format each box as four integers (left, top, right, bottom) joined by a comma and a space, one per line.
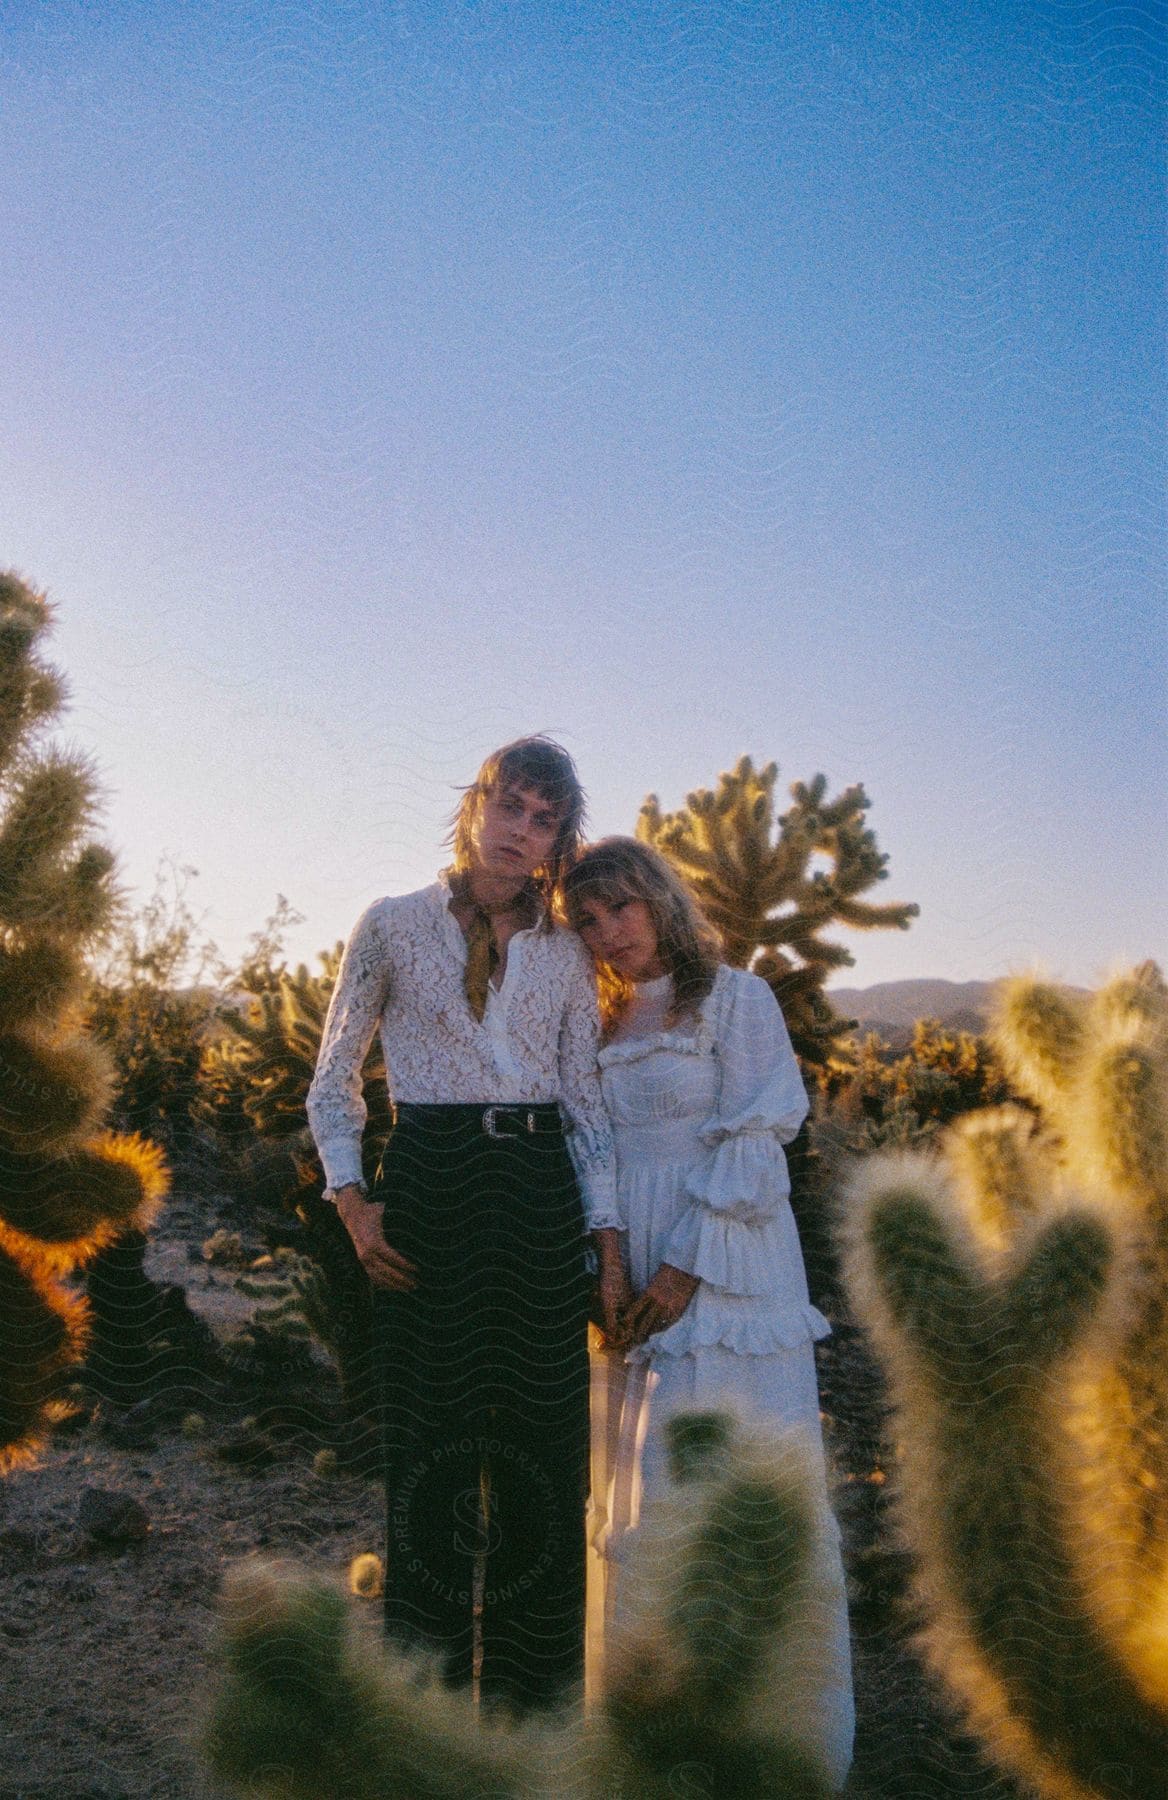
308, 738, 619, 1712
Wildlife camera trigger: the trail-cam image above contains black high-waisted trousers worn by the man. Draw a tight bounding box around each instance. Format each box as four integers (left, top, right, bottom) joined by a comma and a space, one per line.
374, 1105, 588, 1712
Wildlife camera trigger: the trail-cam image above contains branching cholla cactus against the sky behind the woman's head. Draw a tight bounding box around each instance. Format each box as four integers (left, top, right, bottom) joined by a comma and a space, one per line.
637, 756, 920, 1064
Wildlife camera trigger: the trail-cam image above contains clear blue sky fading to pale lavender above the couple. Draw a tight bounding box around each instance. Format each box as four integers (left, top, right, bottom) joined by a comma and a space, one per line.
0, 0, 1168, 985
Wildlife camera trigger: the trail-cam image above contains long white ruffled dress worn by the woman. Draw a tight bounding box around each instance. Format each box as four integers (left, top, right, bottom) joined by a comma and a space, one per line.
588, 965, 855, 1786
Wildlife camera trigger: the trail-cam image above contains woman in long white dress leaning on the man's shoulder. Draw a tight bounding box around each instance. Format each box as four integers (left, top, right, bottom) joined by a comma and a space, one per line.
563, 837, 855, 1786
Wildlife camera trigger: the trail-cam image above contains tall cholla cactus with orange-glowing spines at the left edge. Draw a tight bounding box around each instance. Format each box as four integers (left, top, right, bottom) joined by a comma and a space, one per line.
0, 574, 167, 1472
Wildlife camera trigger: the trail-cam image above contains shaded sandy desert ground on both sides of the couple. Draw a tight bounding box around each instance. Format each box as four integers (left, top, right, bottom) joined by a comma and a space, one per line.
0, 1166, 1013, 1800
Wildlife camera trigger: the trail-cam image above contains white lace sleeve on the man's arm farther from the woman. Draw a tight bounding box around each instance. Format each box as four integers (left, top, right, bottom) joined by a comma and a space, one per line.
306, 902, 391, 1188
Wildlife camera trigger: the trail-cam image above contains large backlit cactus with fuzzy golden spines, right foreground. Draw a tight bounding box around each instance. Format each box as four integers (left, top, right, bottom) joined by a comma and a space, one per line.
848, 963, 1168, 1800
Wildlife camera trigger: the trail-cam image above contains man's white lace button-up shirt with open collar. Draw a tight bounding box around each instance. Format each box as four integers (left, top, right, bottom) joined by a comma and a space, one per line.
308, 875, 619, 1229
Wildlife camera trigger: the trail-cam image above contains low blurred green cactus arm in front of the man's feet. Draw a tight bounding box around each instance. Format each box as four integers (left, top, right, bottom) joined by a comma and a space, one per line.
203, 1564, 533, 1800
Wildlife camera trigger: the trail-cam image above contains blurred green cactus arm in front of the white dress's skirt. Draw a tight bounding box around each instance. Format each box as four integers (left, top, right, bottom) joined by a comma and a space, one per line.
601, 1415, 831, 1800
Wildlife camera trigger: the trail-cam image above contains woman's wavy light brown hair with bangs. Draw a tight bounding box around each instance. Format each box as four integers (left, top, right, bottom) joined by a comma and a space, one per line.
560, 837, 723, 1035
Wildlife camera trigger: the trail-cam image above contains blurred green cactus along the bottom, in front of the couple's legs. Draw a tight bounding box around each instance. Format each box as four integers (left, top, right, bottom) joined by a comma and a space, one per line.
207, 1415, 833, 1800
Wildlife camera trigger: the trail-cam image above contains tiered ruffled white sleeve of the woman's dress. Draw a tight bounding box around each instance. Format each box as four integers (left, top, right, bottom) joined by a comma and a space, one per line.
664, 968, 808, 1294
